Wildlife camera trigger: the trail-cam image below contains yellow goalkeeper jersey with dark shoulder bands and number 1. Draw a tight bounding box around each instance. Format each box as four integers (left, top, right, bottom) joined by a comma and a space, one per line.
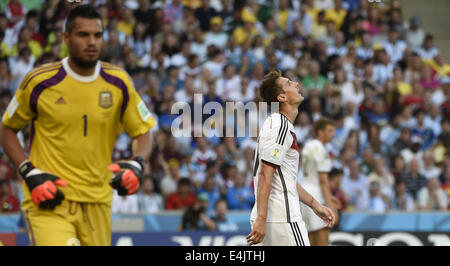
3, 58, 156, 209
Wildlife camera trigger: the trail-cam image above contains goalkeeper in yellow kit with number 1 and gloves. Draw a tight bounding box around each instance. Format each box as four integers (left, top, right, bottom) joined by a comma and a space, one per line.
1, 5, 155, 245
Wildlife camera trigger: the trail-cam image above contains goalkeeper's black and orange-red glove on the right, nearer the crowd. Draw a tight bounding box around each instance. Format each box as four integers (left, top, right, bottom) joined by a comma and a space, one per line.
108, 157, 144, 196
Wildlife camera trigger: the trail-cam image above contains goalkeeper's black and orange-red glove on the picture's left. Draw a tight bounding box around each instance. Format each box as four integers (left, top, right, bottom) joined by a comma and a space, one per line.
18, 160, 67, 210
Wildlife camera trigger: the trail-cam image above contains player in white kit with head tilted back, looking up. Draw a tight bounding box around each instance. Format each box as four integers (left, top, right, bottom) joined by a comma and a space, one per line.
247, 71, 335, 246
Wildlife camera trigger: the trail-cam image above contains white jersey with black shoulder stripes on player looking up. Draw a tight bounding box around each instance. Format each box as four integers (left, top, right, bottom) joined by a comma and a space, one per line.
250, 113, 302, 223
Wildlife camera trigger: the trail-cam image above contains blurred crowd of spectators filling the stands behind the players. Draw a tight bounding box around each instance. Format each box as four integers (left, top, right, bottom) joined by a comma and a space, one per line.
0, 0, 450, 222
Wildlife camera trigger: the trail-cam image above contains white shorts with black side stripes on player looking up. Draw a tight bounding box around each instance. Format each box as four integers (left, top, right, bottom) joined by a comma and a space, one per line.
251, 221, 311, 246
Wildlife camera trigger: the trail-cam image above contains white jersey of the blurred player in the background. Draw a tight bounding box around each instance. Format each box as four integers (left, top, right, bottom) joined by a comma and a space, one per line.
301, 139, 331, 204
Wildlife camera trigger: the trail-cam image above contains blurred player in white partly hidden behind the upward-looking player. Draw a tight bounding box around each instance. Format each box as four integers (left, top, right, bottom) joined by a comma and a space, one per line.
300, 117, 339, 246
